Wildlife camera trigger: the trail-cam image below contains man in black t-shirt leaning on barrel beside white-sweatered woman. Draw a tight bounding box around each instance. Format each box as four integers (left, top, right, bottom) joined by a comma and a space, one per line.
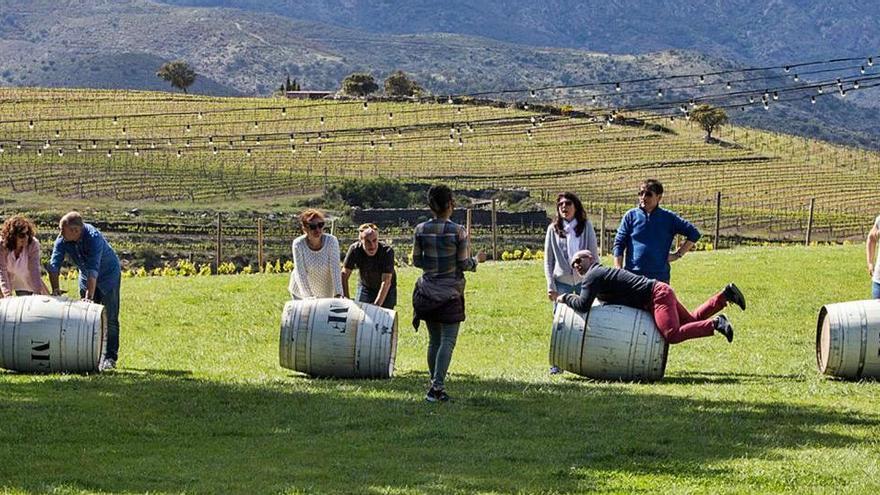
342, 223, 397, 309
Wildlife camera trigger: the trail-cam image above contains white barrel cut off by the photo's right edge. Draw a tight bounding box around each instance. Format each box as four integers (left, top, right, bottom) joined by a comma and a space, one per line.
816, 299, 880, 380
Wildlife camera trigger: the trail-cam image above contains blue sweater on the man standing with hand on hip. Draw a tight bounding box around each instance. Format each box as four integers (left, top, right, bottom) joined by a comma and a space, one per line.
613, 206, 700, 283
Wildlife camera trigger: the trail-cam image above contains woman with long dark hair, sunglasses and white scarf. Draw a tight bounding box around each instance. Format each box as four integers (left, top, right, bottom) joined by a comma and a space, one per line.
544, 192, 599, 375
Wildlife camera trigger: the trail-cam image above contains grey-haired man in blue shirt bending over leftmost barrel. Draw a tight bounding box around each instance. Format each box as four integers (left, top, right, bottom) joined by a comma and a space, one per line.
47, 211, 122, 371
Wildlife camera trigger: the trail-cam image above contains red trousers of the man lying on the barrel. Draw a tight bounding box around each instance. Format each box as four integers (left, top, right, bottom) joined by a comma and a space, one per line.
648, 282, 727, 344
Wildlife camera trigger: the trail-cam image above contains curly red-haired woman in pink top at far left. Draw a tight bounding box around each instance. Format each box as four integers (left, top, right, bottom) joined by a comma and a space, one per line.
0, 215, 49, 297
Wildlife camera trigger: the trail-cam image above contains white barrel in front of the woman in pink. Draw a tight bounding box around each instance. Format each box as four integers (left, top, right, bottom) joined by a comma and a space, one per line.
0, 296, 107, 373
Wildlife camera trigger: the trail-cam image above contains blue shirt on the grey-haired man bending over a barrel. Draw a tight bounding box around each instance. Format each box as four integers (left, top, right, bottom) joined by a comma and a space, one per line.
47, 223, 121, 294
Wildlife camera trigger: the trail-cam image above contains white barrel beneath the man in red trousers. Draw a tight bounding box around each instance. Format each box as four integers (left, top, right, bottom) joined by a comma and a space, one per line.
550, 304, 669, 381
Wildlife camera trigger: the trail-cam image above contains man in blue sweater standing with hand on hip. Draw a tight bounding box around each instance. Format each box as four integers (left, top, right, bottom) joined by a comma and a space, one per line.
612, 179, 700, 283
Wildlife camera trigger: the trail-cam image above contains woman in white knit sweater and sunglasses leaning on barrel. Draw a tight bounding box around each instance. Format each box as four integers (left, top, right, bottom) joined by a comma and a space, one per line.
288, 208, 342, 299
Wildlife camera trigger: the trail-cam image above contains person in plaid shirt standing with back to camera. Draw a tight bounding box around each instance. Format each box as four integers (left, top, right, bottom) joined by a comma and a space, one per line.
413, 185, 486, 402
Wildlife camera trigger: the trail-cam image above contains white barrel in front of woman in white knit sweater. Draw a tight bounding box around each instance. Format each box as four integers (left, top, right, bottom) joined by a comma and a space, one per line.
279, 298, 397, 378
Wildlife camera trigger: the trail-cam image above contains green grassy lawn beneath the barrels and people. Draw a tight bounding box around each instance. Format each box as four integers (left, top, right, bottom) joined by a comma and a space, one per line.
0, 245, 880, 494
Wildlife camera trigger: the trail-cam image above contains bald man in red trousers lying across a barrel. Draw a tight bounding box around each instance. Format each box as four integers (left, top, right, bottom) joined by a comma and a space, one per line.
557, 251, 746, 344
